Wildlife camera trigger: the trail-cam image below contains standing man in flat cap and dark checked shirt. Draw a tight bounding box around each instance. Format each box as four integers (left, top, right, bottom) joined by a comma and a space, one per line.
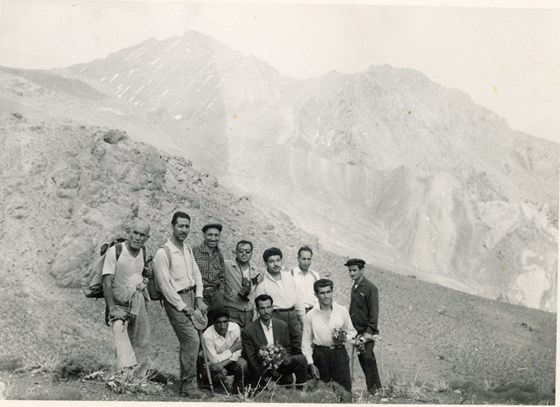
193, 223, 225, 314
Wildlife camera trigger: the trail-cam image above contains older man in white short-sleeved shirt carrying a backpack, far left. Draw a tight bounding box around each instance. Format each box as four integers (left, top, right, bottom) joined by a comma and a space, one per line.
102, 221, 150, 376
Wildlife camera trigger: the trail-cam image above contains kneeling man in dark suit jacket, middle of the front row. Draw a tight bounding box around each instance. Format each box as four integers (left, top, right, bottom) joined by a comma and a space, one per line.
241, 294, 307, 389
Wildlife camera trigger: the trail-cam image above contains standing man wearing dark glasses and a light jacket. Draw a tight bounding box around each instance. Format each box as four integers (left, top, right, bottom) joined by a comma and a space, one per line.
224, 240, 263, 328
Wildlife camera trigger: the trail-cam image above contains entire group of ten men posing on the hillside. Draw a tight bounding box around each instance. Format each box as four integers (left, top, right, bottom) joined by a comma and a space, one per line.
99, 212, 381, 398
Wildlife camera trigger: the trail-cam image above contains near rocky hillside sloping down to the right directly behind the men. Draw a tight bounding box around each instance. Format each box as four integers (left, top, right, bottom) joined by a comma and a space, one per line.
0, 111, 556, 399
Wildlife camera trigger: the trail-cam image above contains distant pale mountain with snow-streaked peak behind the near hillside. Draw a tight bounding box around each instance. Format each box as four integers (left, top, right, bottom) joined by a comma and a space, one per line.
55, 32, 559, 310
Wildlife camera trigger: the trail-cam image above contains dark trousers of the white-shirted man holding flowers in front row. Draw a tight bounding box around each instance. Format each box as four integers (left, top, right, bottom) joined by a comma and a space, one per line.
313, 346, 352, 392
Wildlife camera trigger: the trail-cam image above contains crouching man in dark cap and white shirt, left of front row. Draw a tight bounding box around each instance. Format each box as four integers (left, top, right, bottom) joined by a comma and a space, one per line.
202, 307, 248, 394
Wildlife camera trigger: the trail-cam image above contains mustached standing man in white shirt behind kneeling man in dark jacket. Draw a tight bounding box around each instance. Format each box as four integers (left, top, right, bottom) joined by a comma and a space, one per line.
255, 247, 305, 355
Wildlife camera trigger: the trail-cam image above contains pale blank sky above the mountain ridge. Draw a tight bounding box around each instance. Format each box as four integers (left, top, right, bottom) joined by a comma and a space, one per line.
0, 0, 560, 142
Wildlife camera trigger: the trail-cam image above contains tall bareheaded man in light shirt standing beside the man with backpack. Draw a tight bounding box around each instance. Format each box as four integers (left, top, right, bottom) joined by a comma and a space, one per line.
154, 212, 207, 398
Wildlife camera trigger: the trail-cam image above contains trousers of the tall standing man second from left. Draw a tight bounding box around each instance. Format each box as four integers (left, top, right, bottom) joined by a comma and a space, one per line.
163, 291, 200, 392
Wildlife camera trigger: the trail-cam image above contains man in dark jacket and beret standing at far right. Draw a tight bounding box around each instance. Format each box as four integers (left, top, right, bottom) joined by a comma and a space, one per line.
344, 259, 381, 394
